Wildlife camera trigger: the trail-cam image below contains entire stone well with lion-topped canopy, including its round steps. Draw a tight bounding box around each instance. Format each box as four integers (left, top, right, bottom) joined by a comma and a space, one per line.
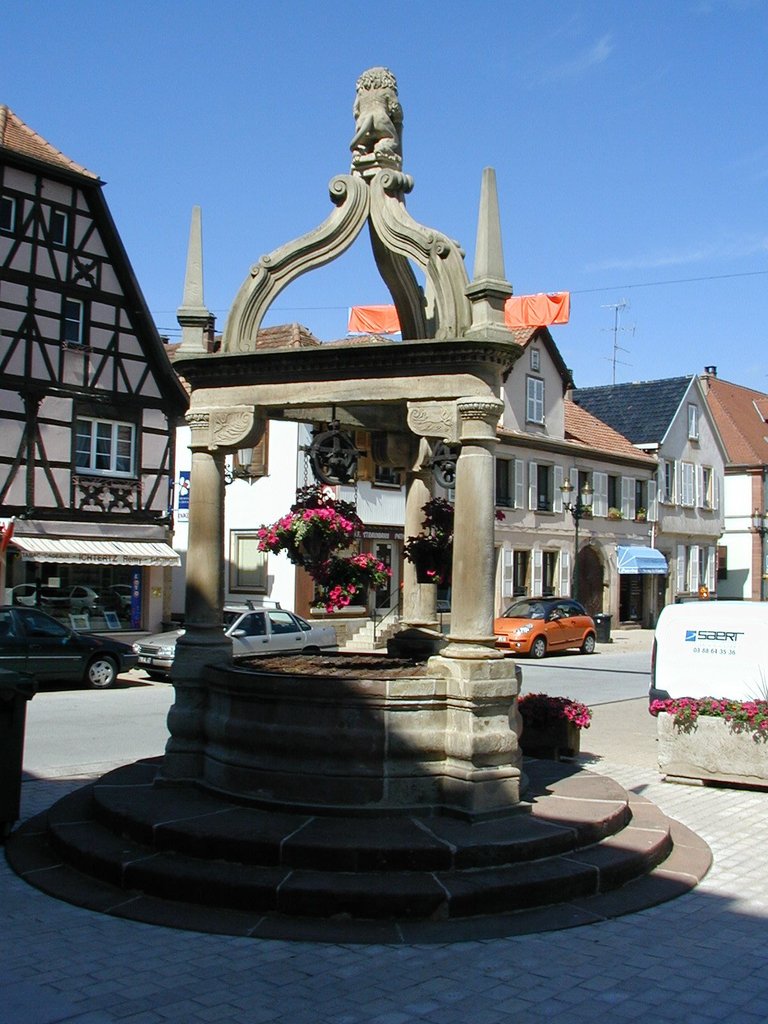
6, 68, 711, 943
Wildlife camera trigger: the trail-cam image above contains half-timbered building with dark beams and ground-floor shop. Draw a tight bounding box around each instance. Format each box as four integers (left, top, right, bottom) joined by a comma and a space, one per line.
0, 106, 187, 629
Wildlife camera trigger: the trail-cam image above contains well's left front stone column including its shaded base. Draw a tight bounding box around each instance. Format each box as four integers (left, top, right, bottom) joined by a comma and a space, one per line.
161, 412, 232, 779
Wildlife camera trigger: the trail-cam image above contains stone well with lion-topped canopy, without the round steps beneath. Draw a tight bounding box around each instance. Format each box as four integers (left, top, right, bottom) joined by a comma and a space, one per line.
162, 68, 521, 817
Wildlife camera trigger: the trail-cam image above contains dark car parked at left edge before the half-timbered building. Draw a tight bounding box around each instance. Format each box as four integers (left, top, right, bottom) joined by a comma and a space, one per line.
0, 605, 136, 689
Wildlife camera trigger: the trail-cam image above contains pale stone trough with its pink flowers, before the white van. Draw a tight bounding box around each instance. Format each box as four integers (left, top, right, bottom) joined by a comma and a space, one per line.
650, 697, 768, 788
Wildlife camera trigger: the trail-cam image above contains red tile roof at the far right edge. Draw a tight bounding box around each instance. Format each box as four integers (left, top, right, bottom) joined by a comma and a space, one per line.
701, 375, 768, 466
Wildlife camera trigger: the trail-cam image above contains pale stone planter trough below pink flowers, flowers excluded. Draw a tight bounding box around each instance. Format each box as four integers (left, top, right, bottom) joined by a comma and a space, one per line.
656, 713, 768, 788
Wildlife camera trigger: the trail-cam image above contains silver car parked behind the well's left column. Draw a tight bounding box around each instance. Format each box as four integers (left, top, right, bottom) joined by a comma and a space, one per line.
133, 605, 338, 679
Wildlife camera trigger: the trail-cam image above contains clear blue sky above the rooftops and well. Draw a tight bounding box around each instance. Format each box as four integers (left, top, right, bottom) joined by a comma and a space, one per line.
0, 0, 768, 391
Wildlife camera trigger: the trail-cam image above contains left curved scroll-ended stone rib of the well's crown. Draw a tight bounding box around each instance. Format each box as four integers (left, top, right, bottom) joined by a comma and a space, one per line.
221, 174, 369, 352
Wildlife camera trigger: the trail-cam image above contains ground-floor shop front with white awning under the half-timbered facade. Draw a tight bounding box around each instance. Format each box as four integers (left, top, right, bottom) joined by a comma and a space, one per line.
3, 520, 180, 632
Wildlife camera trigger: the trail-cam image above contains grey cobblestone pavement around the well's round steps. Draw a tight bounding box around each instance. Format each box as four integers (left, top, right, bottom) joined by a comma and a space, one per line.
0, 634, 768, 1024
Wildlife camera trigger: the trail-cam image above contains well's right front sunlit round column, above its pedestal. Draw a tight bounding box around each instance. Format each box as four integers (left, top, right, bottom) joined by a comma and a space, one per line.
443, 395, 504, 658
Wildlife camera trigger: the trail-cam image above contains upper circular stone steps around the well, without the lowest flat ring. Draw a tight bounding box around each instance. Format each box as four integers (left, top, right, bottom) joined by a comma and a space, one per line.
33, 762, 673, 921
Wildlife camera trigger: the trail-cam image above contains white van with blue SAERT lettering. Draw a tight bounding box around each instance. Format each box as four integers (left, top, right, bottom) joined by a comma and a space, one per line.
649, 601, 768, 700
